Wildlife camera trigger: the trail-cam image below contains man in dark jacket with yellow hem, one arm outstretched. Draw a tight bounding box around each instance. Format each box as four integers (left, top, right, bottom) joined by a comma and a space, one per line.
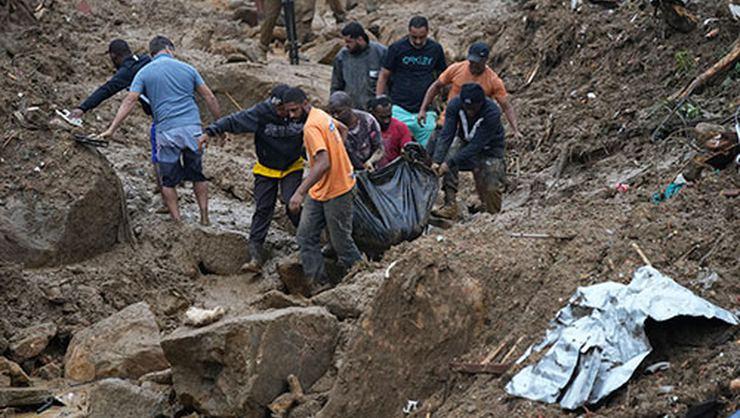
199, 84, 304, 271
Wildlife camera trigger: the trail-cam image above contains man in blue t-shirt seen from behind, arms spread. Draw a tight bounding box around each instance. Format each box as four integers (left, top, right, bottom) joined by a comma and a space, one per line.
98, 36, 221, 225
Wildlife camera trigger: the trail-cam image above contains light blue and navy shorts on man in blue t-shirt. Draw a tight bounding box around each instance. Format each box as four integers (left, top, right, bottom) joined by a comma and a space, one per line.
157, 126, 208, 187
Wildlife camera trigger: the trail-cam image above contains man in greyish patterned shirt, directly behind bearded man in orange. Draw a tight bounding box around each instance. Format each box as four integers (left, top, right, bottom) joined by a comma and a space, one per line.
329, 91, 383, 171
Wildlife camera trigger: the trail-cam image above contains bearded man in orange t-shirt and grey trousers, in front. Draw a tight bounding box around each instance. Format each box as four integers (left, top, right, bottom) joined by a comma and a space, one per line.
283, 88, 362, 294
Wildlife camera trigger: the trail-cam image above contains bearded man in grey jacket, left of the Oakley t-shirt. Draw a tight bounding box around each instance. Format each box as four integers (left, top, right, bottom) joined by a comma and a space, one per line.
331, 22, 387, 110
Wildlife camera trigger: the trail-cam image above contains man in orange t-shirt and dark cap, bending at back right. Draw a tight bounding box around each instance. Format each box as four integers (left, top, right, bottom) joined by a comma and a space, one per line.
418, 42, 522, 138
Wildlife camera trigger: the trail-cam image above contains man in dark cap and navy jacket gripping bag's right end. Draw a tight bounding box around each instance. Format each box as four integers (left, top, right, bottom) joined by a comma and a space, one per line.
433, 83, 506, 219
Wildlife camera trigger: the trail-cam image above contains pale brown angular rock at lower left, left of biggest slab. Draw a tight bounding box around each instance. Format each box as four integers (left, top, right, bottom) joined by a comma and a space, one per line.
64, 302, 169, 382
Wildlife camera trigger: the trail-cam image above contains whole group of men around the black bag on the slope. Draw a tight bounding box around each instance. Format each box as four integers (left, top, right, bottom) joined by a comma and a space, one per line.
72, 16, 520, 291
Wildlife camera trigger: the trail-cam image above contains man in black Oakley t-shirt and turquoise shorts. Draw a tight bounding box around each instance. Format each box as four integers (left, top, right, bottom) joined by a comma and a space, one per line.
375, 16, 447, 146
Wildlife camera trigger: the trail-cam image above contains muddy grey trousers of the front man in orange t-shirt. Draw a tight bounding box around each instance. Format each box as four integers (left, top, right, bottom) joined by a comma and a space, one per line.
296, 191, 362, 282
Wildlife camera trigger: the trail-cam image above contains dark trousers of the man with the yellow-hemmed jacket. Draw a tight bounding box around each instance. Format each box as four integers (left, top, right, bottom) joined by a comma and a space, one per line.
249, 170, 303, 246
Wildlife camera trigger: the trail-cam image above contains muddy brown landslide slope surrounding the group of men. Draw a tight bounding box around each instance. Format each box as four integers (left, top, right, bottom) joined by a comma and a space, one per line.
0, 0, 740, 418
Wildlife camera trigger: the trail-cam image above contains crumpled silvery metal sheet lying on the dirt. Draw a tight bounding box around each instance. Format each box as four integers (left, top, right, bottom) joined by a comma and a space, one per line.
506, 266, 738, 409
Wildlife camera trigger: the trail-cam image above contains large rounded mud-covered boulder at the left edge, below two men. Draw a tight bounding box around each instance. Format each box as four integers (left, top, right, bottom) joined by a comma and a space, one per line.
0, 138, 130, 267
